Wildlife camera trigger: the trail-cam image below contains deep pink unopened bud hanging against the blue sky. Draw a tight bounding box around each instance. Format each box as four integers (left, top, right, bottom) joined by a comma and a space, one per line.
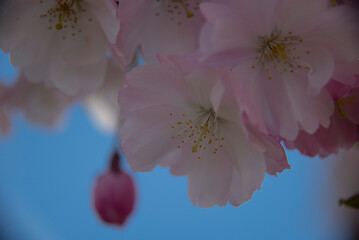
93, 153, 135, 226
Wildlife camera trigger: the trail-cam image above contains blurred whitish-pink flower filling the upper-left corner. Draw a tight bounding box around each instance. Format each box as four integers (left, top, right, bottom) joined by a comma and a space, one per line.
0, 0, 119, 95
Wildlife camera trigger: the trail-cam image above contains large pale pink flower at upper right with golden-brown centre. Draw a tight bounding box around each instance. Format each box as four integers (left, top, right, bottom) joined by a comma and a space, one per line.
197, 0, 359, 140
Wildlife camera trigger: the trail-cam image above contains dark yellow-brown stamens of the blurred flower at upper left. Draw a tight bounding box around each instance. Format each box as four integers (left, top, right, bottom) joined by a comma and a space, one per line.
40, 0, 92, 40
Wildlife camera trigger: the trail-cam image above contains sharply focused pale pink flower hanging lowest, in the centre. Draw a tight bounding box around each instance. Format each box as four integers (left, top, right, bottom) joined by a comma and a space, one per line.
119, 56, 289, 207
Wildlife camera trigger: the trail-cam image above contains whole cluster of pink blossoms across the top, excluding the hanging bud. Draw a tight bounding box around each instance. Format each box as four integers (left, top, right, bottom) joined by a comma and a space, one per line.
0, 0, 359, 208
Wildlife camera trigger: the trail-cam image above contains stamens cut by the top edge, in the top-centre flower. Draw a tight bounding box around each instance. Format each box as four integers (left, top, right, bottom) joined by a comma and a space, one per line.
155, 0, 199, 25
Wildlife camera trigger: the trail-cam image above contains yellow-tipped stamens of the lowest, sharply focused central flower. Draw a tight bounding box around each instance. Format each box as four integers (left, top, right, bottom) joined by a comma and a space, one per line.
169, 107, 224, 159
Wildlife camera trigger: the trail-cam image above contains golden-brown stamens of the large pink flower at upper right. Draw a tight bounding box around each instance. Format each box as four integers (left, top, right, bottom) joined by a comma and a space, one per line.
252, 27, 310, 80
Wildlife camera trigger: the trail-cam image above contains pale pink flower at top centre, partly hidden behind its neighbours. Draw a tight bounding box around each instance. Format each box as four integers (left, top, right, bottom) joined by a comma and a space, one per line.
117, 0, 204, 63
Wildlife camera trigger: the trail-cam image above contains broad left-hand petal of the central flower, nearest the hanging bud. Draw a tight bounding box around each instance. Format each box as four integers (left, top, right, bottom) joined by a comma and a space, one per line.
120, 105, 188, 171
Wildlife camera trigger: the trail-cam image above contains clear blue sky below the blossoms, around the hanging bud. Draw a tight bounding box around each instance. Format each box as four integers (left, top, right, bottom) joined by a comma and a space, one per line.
0, 54, 352, 240
